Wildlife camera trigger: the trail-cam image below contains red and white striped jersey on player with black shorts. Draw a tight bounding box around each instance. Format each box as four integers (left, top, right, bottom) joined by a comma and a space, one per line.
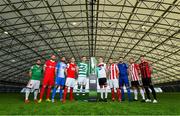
129, 63, 140, 81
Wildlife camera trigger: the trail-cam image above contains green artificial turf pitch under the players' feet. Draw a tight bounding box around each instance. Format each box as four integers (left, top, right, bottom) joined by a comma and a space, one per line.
0, 93, 180, 115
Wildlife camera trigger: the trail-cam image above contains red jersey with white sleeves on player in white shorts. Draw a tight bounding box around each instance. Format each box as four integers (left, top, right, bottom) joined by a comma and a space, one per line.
67, 63, 76, 78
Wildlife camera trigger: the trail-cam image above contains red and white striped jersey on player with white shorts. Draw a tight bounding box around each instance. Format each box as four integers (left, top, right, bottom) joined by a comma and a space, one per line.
108, 64, 119, 80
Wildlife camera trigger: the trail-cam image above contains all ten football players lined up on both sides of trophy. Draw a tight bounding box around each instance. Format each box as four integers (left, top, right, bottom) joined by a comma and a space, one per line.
25, 55, 157, 103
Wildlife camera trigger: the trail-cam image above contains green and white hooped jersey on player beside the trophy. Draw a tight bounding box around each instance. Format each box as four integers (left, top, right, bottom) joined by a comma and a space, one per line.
78, 62, 88, 77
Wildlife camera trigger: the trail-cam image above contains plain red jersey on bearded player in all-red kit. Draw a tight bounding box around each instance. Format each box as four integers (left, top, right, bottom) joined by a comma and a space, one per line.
44, 60, 56, 78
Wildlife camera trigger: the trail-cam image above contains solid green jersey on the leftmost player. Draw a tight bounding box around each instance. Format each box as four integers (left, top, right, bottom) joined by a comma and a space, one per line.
30, 65, 43, 80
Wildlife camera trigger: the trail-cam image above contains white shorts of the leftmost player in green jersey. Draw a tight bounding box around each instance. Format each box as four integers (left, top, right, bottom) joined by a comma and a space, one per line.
26, 80, 40, 89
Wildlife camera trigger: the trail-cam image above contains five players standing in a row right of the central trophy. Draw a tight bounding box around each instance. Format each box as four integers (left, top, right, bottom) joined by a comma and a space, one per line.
97, 56, 157, 103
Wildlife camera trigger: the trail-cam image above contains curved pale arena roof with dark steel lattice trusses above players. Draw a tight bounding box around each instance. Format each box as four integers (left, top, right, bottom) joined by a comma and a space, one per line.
0, 0, 180, 83
